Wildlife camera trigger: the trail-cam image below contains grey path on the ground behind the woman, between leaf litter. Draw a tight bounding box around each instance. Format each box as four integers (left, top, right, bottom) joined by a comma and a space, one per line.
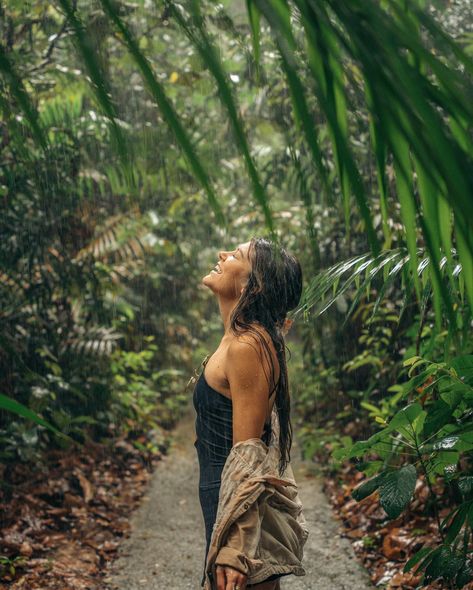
106, 406, 374, 590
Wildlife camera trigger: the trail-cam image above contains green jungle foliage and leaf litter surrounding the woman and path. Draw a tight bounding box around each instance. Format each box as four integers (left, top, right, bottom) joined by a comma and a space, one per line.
0, 0, 473, 590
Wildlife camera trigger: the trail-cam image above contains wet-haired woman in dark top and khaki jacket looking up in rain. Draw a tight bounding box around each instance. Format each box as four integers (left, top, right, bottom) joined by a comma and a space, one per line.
194, 238, 307, 590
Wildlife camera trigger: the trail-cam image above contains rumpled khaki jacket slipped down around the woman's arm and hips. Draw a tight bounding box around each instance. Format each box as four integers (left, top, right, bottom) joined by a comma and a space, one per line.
204, 408, 309, 590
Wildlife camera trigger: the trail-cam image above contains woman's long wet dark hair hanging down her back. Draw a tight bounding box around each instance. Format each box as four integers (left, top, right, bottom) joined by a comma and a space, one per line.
230, 237, 302, 475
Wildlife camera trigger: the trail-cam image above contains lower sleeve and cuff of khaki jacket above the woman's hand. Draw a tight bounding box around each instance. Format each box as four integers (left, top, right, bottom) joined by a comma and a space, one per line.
215, 497, 264, 575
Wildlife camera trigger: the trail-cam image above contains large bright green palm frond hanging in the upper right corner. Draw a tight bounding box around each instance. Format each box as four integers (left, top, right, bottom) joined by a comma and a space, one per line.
247, 0, 473, 318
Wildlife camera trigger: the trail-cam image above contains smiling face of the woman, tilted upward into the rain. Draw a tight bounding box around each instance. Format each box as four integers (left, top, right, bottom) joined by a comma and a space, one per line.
202, 242, 251, 299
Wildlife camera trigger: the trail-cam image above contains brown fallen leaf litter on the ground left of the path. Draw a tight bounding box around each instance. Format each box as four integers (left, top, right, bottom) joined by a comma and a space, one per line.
0, 438, 167, 590
